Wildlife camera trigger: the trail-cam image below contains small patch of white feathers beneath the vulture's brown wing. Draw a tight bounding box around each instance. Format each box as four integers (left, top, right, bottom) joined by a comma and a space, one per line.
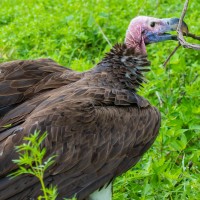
89, 183, 112, 200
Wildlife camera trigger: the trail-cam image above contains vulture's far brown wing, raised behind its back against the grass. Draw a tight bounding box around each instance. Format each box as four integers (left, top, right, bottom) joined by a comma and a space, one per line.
0, 59, 71, 117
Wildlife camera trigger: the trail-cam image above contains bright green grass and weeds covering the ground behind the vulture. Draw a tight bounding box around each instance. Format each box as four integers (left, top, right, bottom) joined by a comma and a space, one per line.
0, 0, 200, 200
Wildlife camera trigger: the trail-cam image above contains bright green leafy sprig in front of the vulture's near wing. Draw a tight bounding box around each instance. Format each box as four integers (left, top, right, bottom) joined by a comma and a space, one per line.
9, 131, 58, 200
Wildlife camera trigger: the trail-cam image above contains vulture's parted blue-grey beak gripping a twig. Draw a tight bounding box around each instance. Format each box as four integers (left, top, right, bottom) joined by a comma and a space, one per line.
144, 18, 188, 44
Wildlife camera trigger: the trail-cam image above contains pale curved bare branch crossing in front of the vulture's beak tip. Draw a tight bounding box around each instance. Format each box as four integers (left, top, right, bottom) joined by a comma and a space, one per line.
177, 0, 200, 50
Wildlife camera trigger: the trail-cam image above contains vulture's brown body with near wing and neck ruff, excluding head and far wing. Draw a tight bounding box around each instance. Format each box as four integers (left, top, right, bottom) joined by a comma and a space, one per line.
0, 45, 160, 200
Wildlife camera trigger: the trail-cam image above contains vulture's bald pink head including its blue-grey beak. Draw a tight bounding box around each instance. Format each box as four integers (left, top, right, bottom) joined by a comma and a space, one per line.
125, 16, 188, 54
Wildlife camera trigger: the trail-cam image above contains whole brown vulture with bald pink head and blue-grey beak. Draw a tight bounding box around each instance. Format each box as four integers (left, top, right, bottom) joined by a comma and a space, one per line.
0, 16, 187, 200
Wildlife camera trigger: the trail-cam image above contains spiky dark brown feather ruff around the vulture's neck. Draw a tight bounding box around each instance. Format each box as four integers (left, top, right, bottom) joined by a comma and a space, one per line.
92, 44, 150, 91
